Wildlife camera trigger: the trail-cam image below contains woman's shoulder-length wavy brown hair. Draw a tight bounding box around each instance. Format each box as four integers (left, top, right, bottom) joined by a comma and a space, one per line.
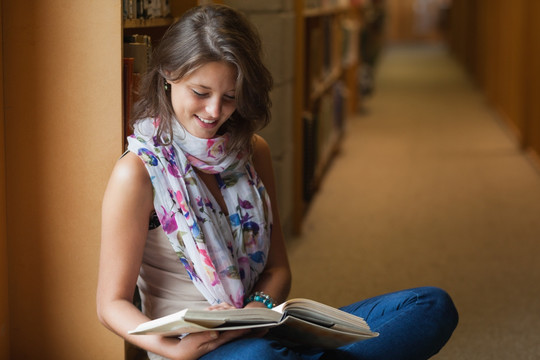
131, 4, 273, 150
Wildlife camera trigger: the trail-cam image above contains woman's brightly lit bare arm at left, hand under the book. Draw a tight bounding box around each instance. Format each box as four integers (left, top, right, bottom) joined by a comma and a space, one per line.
97, 153, 247, 360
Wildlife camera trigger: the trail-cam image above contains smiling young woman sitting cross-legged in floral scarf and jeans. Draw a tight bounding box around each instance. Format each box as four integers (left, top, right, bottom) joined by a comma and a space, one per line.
97, 5, 457, 359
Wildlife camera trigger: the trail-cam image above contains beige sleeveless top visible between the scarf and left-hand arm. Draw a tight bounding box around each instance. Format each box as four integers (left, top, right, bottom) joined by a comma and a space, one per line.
137, 226, 209, 319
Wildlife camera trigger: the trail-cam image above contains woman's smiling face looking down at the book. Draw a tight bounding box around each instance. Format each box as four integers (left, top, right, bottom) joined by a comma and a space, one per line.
170, 62, 236, 139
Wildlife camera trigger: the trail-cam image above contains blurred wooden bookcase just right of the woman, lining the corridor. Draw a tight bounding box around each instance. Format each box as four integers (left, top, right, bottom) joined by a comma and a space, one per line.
294, 0, 361, 233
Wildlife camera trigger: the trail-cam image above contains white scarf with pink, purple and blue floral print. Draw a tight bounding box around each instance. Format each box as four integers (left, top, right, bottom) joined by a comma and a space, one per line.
128, 118, 272, 308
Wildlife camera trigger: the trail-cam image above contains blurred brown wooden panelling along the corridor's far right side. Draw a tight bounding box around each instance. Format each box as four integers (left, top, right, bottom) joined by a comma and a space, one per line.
449, 0, 540, 166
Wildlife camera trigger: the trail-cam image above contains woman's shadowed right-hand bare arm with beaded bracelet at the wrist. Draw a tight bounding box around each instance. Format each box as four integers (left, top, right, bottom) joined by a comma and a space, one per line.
248, 136, 291, 307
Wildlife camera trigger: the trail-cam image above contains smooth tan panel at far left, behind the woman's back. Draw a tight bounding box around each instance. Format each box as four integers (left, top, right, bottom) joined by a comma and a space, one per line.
0, 0, 123, 359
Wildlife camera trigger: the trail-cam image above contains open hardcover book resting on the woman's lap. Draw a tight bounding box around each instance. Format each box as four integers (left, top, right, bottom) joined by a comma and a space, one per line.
129, 299, 378, 349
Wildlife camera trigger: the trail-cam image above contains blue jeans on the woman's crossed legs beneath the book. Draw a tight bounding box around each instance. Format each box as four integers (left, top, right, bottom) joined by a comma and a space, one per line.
201, 287, 458, 360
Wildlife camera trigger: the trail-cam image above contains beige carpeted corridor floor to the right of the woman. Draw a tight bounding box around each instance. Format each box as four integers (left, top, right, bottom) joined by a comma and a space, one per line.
288, 45, 540, 360
